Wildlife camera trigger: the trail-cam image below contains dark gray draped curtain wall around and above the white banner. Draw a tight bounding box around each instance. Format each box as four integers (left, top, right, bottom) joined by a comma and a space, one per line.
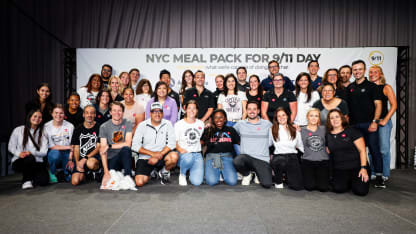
0, 0, 416, 161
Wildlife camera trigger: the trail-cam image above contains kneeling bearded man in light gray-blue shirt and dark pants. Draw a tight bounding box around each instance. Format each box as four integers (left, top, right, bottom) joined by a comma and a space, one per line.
233, 101, 273, 188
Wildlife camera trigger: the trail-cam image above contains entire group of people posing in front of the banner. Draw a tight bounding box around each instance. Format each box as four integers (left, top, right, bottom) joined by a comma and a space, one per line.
9, 60, 397, 195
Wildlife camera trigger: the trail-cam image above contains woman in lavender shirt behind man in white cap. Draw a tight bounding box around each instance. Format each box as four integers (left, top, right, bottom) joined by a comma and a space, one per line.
146, 81, 178, 125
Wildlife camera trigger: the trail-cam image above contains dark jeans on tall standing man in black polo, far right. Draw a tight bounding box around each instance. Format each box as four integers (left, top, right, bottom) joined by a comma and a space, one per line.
354, 123, 383, 176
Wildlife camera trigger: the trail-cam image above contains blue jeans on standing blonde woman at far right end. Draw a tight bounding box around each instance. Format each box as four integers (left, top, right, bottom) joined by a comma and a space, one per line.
371, 119, 393, 177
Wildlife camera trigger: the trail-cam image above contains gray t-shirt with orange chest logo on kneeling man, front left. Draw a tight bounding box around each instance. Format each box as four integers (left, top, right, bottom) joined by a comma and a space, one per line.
100, 119, 133, 159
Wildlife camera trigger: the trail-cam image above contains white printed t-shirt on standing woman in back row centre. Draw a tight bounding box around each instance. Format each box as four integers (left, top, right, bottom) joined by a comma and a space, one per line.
217, 91, 247, 121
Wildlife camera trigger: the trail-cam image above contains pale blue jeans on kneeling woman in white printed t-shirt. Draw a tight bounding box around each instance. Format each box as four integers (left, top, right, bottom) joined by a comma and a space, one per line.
178, 152, 204, 186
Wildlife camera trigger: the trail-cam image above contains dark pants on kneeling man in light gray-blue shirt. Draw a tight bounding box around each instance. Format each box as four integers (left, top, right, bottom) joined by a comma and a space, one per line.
233, 154, 273, 188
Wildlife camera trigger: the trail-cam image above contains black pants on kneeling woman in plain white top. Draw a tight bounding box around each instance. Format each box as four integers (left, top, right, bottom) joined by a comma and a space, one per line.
271, 154, 303, 190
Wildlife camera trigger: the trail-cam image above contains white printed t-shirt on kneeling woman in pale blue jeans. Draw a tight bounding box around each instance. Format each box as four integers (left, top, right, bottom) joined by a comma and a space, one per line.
175, 119, 204, 153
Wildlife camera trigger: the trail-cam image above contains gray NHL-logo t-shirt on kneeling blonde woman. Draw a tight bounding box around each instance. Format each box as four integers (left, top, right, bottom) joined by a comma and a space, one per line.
301, 126, 329, 161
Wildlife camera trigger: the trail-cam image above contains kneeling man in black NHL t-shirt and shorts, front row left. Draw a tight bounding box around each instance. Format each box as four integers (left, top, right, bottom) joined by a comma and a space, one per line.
71, 105, 100, 185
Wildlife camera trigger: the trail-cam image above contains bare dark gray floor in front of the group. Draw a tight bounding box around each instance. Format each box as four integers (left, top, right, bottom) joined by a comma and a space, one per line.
0, 170, 416, 233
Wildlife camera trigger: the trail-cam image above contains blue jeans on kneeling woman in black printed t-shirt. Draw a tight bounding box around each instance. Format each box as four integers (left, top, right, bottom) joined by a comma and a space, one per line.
205, 153, 237, 186
